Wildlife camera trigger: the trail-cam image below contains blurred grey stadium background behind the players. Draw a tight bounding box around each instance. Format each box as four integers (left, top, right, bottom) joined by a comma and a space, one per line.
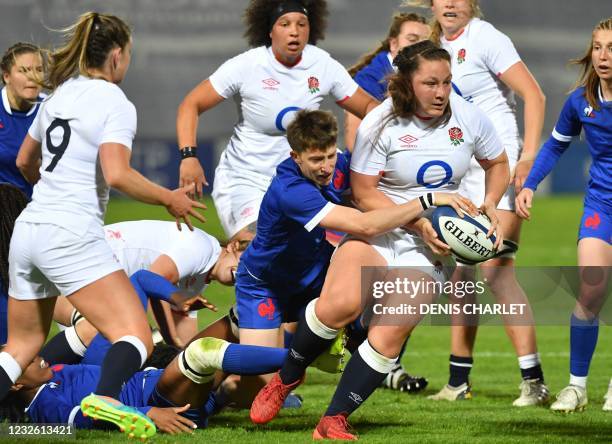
0, 0, 611, 193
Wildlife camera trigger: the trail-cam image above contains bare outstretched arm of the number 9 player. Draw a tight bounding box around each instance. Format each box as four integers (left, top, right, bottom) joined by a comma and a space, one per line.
100, 143, 206, 230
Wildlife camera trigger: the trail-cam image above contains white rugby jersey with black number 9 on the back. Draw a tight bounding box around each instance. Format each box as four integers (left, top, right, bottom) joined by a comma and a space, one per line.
19, 76, 136, 235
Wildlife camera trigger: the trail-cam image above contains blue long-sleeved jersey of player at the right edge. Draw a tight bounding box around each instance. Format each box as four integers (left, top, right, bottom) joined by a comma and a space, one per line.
525, 87, 612, 214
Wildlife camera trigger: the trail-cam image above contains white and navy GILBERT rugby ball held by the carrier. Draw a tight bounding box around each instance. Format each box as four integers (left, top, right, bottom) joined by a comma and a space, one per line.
431, 206, 495, 264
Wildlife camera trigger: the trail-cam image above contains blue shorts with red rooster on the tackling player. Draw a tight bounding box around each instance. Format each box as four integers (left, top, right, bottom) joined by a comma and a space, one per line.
236, 267, 327, 330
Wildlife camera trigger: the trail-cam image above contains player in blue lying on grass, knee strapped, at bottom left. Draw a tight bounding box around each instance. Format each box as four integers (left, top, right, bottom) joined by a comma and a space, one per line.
0, 338, 294, 438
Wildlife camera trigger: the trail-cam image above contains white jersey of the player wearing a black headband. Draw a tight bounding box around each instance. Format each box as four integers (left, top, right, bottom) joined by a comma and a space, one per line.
209, 45, 358, 177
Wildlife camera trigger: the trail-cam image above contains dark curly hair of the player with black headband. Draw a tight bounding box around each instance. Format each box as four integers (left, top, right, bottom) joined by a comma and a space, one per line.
244, 0, 329, 48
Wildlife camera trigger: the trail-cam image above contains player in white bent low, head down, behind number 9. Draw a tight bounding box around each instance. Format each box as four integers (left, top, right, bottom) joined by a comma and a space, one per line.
41, 220, 247, 364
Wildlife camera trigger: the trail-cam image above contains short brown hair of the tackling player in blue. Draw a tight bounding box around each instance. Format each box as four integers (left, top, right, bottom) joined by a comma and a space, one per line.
287, 109, 338, 153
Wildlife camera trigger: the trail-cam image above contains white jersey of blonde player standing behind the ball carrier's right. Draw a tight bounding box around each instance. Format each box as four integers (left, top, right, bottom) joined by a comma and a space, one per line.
440, 18, 521, 146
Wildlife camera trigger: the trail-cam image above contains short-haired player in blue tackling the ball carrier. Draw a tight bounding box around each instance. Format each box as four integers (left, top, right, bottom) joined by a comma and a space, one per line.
230, 106, 475, 406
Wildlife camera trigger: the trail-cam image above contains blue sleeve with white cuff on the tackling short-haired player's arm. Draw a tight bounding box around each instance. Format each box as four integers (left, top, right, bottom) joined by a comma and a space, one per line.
280, 181, 334, 231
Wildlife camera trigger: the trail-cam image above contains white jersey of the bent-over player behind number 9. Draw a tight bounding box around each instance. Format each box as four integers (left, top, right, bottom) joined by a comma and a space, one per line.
104, 220, 221, 296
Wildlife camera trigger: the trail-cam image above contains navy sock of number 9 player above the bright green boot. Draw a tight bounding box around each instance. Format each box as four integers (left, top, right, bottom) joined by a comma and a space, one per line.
95, 341, 142, 399
